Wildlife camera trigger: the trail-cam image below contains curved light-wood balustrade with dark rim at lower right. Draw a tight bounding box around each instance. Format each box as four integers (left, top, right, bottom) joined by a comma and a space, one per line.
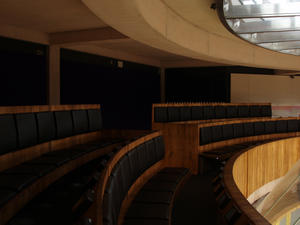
224, 137, 300, 225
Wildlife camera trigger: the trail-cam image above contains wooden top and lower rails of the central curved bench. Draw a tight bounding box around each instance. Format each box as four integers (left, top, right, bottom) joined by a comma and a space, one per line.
94, 131, 165, 225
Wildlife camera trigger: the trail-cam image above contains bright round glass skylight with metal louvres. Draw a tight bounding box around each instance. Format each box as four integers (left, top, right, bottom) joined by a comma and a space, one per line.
220, 0, 300, 55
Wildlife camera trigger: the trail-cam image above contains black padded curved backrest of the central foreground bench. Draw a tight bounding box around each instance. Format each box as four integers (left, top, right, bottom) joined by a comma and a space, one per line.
102, 136, 165, 225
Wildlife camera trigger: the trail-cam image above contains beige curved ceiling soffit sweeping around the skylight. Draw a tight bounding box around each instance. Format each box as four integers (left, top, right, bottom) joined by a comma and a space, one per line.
82, 0, 300, 70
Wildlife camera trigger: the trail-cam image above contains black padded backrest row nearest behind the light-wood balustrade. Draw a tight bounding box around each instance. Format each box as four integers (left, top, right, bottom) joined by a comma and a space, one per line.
200, 119, 300, 145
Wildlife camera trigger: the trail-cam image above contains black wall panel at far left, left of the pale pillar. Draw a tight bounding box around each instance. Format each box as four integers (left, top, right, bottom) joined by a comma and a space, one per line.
0, 37, 47, 106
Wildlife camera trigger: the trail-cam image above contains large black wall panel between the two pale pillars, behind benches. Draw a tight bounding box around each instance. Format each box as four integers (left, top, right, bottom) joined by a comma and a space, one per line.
61, 49, 160, 129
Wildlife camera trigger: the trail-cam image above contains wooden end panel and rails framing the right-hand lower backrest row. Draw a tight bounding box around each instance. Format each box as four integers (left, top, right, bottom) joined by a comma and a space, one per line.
156, 117, 300, 174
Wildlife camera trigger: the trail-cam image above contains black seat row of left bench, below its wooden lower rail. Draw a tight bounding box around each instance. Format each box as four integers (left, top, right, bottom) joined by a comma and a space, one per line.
0, 129, 124, 210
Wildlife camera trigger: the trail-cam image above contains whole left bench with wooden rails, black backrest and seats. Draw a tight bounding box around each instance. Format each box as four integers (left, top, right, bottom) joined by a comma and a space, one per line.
0, 105, 146, 224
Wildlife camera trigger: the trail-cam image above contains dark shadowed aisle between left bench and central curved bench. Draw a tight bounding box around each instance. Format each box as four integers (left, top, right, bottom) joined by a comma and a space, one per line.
8, 149, 118, 225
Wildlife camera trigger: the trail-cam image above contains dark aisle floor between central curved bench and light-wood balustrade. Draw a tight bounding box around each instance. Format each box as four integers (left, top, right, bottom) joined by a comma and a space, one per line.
172, 172, 222, 225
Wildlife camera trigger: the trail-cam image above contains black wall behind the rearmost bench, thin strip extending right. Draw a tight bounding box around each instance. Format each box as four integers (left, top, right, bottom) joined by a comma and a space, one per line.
166, 66, 274, 102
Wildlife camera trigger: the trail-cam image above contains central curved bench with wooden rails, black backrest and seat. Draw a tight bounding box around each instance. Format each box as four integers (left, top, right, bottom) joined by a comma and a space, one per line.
96, 131, 190, 225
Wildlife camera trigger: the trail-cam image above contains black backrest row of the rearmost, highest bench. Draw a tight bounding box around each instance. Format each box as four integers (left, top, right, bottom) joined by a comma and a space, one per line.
154, 105, 272, 123
